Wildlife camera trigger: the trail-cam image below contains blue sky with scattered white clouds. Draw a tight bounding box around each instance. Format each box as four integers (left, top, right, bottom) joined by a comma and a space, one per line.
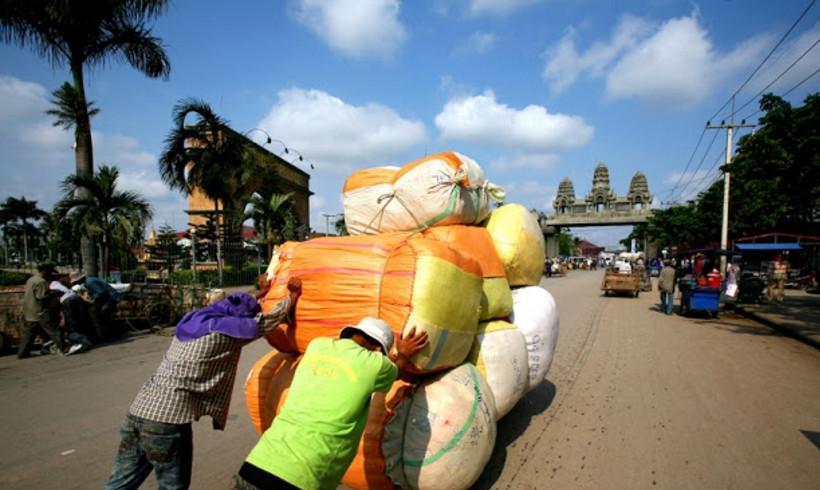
0, 0, 820, 245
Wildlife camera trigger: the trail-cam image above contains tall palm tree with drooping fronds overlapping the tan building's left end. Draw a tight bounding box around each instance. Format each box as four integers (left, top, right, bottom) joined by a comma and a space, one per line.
159, 98, 253, 284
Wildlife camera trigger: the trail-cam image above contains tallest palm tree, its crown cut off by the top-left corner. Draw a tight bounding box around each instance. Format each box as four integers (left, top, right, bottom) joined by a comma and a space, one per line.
0, 0, 171, 274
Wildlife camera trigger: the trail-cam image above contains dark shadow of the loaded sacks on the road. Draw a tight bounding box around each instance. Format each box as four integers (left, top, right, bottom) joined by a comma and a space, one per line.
471, 379, 557, 490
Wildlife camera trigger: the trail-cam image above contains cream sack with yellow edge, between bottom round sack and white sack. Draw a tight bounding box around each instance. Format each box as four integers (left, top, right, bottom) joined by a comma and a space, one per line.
468, 320, 529, 419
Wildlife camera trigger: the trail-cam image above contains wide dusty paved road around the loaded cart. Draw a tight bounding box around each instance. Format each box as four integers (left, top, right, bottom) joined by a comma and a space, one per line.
0, 271, 820, 490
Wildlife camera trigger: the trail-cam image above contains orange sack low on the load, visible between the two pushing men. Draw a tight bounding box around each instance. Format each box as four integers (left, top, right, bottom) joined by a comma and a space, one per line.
245, 350, 300, 435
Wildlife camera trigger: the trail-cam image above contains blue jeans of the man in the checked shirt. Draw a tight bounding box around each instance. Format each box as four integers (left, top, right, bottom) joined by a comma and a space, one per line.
105, 414, 194, 490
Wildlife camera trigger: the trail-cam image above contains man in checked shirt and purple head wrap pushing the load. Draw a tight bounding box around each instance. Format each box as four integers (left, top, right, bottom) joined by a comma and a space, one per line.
105, 277, 302, 490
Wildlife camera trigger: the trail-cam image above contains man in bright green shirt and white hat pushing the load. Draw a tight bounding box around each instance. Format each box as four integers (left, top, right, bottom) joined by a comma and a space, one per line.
236, 317, 427, 490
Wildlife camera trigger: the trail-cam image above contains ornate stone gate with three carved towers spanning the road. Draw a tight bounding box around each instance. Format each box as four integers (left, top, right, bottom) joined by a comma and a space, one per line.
541, 162, 652, 257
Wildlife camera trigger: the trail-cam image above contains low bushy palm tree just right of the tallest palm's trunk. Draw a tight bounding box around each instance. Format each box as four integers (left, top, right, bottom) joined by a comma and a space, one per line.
54, 165, 152, 277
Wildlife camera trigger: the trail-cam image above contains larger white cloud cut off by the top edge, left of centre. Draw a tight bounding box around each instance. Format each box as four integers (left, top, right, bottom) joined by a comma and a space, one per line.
295, 0, 407, 58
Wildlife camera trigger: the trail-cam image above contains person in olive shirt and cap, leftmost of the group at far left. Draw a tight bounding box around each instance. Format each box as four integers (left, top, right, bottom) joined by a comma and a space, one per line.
17, 264, 64, 359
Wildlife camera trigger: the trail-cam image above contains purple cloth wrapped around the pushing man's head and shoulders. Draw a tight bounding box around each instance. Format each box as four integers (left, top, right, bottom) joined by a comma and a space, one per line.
176, 292, 260, 342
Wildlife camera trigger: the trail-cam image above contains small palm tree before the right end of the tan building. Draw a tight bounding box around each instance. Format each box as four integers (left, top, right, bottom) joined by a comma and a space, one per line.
245, 192, 297, 257
